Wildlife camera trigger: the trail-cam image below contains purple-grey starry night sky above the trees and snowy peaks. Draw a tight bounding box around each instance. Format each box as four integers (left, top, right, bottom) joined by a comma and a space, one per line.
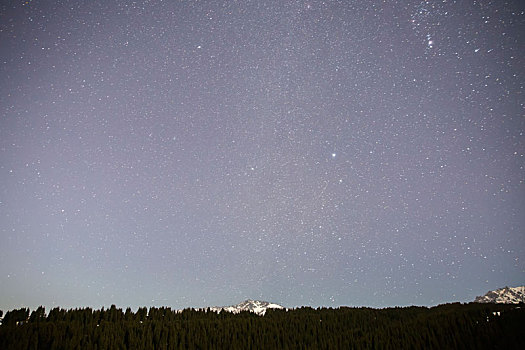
0, 0, 525, 311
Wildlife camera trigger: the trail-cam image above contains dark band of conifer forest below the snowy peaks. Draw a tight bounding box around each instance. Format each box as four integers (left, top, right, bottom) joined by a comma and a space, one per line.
0, 303, 525, 350
